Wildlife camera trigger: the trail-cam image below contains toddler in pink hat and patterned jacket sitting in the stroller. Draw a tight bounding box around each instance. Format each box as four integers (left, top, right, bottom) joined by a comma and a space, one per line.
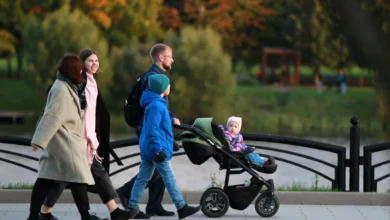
218, 116, 275, 167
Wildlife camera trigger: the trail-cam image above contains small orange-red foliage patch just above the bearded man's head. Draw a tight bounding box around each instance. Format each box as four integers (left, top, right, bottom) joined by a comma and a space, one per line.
158, 6, 183, 30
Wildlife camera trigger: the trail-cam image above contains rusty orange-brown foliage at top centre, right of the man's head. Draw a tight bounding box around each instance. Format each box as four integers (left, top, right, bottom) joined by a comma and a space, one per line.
184, 0, 276, 49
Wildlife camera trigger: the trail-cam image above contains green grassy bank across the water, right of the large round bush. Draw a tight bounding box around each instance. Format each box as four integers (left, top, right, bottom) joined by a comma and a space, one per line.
231, 86, 382, 136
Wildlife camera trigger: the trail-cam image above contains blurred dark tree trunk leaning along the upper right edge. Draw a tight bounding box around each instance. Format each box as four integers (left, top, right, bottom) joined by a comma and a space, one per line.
332, 0, 390, 138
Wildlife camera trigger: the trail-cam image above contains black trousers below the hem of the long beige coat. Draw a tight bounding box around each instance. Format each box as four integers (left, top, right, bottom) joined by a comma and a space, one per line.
29, 178, 90, 219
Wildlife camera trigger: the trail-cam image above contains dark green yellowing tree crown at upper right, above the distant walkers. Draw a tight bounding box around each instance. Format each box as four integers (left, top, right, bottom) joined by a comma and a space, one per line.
266, 0, 350, 68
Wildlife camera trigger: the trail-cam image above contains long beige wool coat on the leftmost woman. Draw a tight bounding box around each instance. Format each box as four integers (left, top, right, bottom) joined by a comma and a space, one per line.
31, 79, 95, 185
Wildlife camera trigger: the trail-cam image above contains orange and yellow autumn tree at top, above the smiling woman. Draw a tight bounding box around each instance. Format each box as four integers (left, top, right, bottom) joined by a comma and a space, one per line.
71, 0, 163, 50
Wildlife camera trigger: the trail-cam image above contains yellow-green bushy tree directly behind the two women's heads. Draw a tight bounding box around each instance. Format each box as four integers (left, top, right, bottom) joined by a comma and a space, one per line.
23, 5, 112, 91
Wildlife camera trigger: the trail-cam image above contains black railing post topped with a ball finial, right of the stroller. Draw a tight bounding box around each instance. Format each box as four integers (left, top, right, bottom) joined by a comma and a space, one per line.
349, 116, 360, 192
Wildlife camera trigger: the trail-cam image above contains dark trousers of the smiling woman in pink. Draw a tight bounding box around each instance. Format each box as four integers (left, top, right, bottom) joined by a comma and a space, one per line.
44, 159, 118, 207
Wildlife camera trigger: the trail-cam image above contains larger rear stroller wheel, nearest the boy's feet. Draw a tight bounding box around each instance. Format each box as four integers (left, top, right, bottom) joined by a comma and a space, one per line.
200, 187, 229, 218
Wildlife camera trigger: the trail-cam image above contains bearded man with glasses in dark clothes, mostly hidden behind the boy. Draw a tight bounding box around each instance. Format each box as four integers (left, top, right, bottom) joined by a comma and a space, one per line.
117, 44, 180, 219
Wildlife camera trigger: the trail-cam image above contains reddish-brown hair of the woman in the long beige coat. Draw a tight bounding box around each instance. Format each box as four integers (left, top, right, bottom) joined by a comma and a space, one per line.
57, 55, 84, 84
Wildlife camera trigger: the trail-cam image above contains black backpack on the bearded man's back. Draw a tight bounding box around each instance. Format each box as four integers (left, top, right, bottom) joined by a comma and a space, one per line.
123, 74, 146, 128
